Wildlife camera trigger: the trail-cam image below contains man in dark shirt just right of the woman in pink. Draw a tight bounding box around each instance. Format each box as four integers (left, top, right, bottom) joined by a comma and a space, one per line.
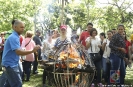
33, 30, 42, 74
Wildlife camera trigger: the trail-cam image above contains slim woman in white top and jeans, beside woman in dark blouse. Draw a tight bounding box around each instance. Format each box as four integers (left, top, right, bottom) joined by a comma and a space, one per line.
102, 31, 113, 83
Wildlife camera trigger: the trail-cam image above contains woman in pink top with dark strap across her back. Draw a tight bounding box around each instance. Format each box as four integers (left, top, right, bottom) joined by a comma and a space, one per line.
22, 31, 35, 81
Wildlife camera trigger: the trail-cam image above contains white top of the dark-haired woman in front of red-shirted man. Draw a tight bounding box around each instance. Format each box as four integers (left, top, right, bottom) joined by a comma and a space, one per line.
85, 37, 101, 53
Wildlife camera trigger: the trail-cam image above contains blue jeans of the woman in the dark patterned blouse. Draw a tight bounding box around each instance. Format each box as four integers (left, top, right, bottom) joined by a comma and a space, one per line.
109, 53, 125, 84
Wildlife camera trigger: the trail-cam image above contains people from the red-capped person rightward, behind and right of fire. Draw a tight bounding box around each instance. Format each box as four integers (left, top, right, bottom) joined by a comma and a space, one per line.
42, 23, 133, 87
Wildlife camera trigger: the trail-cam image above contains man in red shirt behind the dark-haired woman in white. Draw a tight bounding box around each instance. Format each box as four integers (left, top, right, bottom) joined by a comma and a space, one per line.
79, 23, 93, 47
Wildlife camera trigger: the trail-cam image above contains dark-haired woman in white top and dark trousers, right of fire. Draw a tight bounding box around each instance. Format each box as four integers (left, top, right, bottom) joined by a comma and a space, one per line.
86, 28, 102, 87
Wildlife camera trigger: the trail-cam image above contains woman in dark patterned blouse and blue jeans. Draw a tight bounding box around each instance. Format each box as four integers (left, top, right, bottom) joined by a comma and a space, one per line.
109, 24, 126, 85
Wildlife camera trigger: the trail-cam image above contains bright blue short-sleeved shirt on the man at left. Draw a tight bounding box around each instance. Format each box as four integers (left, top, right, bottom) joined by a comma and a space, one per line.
2, 31, 20, 67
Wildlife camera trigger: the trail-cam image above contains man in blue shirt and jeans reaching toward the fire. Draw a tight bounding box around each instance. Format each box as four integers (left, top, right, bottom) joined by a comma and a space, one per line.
2, 20, 40, 87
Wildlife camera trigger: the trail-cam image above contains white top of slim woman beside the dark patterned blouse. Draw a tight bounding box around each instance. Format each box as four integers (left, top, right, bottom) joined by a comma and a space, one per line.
103, 39, 111, 58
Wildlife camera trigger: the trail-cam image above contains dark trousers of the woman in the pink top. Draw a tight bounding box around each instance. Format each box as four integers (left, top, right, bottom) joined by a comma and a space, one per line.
22, 61, 32, 80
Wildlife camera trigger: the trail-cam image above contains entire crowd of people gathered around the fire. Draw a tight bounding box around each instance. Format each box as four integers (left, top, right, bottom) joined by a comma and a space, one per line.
0, 20, 133, 87
